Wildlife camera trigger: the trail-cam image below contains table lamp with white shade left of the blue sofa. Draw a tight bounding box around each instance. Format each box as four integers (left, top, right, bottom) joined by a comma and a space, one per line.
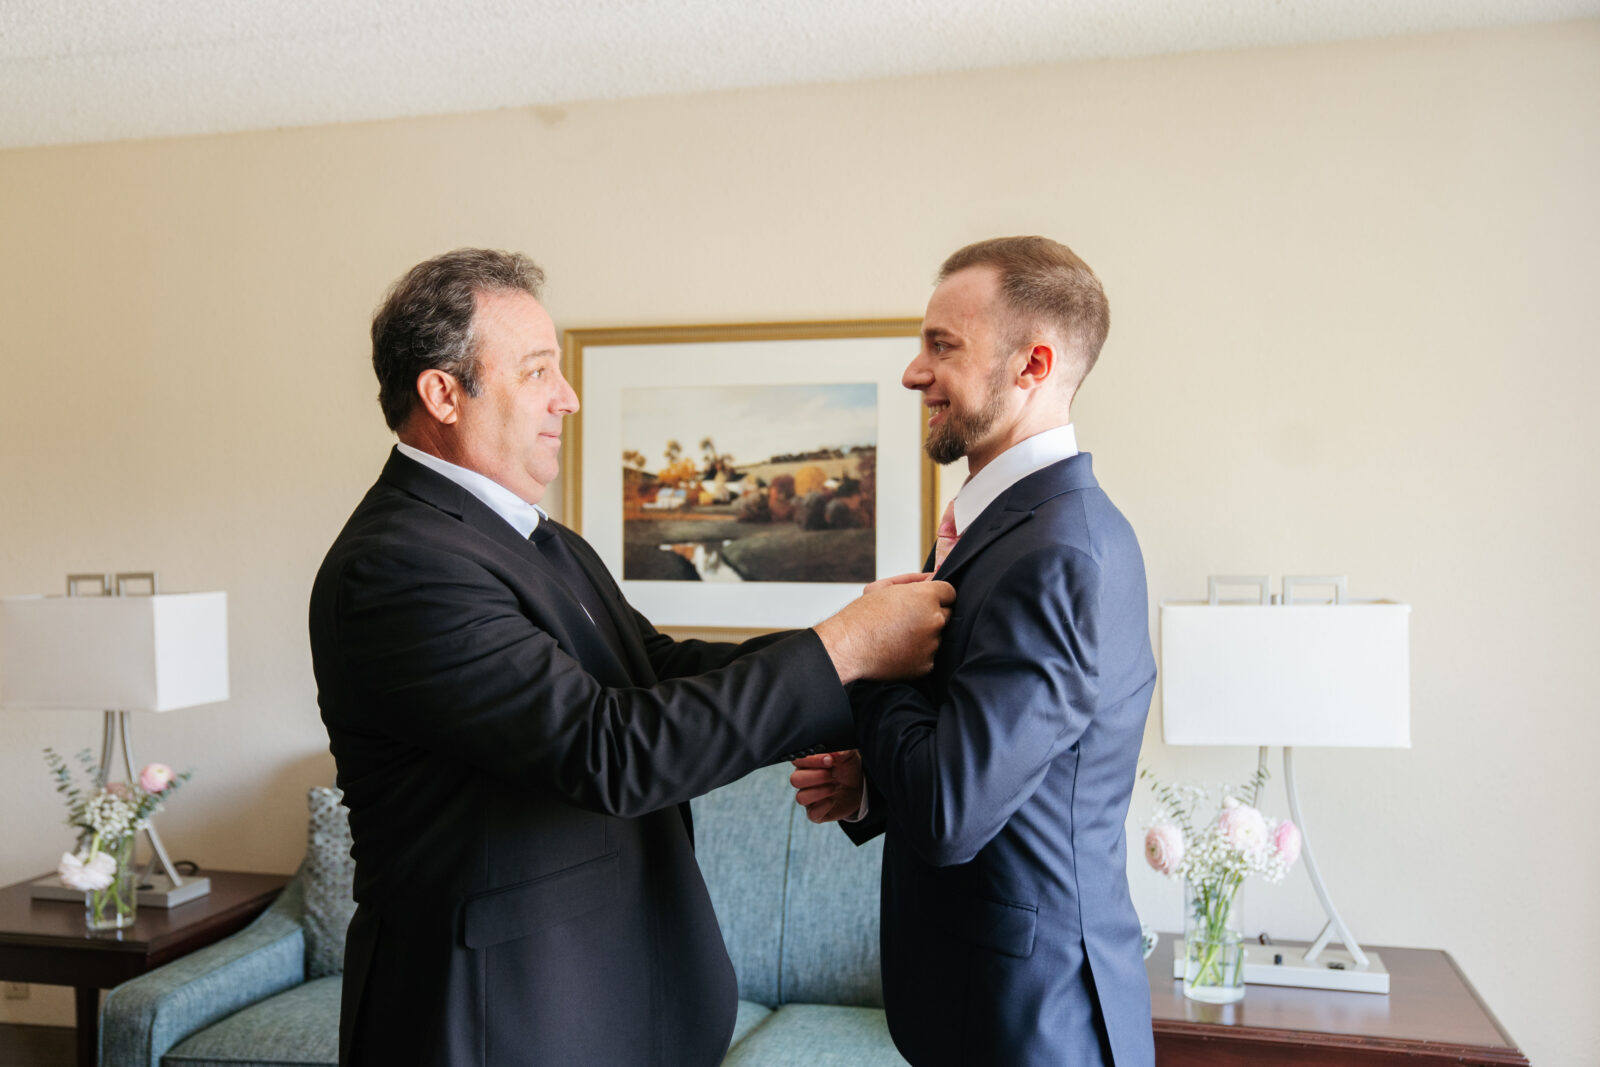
0, 573, 229, 907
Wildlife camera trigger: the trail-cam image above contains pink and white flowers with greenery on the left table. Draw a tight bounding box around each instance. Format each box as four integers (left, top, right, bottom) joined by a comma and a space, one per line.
45, 749, 189, 893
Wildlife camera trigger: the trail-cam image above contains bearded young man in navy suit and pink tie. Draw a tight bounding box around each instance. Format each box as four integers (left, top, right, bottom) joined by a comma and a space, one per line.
792, 237, 1155, 1067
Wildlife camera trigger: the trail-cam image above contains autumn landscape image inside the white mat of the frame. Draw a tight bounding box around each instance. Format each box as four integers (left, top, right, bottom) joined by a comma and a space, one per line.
619, 382, 878, 584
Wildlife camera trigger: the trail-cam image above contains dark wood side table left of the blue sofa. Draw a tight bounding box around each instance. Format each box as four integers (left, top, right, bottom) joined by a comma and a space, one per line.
0, 870, 288, 1067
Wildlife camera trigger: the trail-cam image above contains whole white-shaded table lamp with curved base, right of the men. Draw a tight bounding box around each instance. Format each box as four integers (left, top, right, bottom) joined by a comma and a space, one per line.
1162, 576, 1411, 993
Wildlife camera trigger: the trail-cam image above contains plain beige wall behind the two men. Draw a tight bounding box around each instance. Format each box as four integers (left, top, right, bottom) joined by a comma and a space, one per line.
0, 21, 1600, 1064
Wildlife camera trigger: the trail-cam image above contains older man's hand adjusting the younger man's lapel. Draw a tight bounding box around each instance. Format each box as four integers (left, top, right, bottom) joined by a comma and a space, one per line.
816, 574, 955, 685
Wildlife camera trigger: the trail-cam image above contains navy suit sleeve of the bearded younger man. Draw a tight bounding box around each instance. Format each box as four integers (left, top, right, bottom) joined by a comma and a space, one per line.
858, 545, 1101, 867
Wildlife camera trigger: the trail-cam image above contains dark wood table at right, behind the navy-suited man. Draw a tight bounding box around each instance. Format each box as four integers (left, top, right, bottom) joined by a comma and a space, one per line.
1144, 934, 1528, 1067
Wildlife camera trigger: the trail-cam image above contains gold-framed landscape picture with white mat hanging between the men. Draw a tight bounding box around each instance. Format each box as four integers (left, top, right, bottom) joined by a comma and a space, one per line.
563, 318, 938, 633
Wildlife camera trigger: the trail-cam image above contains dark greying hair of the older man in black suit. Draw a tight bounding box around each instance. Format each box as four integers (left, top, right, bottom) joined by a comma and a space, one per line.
373, 248, 544, 430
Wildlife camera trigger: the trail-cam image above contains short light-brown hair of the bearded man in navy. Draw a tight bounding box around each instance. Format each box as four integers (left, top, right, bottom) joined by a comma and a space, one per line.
939, 237, 1110, 390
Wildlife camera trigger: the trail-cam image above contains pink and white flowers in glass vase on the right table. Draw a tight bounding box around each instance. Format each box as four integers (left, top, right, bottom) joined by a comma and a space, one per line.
1139, 768, 1302, 985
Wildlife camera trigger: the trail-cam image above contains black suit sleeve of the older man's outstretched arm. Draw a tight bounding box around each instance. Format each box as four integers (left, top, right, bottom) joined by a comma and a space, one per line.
314, 544, 853, 816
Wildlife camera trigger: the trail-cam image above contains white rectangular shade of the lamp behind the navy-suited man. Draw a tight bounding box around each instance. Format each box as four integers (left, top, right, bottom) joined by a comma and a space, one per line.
1162, 601, 1411, 749
